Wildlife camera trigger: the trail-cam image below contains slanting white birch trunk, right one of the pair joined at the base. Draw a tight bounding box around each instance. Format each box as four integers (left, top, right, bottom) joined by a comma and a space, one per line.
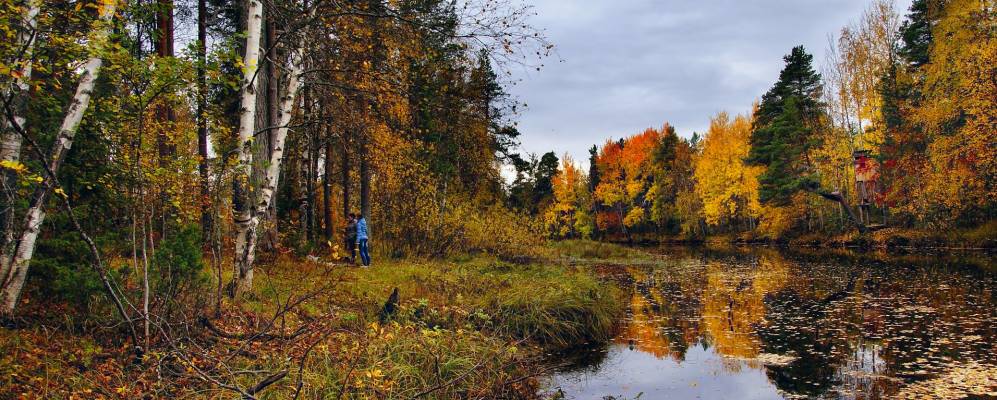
235, 49, 302, 289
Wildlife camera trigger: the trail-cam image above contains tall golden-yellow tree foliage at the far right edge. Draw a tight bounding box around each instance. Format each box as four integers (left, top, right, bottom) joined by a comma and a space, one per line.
914, 0, 997, 220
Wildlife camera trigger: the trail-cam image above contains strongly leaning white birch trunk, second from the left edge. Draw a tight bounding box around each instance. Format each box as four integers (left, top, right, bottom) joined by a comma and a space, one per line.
0, 0, 117, 317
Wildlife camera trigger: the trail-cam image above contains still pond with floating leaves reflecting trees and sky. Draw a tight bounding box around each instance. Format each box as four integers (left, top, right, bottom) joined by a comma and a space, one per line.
548, 248, 997, 399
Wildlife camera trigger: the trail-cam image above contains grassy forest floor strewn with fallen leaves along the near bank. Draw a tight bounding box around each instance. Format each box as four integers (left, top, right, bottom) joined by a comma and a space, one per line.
0, 242, 641, 399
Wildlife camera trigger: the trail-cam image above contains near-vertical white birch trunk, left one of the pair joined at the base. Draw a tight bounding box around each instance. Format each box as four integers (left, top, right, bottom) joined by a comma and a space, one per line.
229, 0, 263, 297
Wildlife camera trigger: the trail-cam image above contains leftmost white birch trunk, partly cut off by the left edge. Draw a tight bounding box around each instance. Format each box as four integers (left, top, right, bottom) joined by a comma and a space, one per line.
0, 0, 41, 277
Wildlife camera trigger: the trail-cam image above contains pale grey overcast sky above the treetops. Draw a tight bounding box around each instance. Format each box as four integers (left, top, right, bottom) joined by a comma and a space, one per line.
509, 0, 910, 165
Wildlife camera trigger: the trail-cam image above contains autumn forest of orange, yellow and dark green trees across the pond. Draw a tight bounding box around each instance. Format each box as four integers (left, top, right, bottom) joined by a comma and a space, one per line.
535, 1, 997, 247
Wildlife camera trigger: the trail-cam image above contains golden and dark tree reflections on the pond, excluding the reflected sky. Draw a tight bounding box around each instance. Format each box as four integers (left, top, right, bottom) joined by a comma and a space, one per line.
580, 249, 997, 399
